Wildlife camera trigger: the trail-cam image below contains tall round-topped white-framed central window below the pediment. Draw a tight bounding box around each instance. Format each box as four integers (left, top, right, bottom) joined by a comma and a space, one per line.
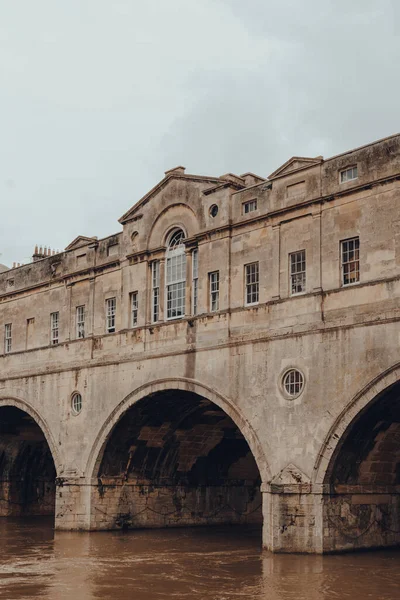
165, 229, 186, 319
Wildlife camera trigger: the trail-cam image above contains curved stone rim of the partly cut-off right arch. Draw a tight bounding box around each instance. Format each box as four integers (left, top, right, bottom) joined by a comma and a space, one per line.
312, 363, 400, 484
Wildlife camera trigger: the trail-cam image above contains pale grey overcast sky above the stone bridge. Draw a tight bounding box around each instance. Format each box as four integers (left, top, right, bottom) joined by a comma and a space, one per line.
0, 0, 400, 266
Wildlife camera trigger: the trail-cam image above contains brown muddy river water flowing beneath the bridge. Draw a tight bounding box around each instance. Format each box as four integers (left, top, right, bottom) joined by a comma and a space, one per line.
0, 519, 400, 600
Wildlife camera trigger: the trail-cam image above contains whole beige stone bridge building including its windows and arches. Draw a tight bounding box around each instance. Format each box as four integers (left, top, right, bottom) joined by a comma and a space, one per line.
0, 135, 400, 553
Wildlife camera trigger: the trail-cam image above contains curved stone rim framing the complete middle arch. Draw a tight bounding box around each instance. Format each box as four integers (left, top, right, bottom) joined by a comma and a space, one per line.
85, 377, 271, 484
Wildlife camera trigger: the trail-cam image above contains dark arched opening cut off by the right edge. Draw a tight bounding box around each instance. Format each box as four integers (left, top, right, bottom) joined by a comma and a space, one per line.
324, 382, 400, 550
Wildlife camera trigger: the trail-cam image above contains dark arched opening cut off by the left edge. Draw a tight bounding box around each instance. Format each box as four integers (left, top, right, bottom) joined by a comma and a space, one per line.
0, 405, 56, 517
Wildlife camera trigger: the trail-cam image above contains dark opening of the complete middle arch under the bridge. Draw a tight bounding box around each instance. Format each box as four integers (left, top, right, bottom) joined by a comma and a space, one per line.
91, 389, 262, 530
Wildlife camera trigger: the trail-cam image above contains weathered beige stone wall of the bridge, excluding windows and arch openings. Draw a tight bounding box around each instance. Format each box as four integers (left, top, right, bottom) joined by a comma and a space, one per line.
0, 136, 400, 551
